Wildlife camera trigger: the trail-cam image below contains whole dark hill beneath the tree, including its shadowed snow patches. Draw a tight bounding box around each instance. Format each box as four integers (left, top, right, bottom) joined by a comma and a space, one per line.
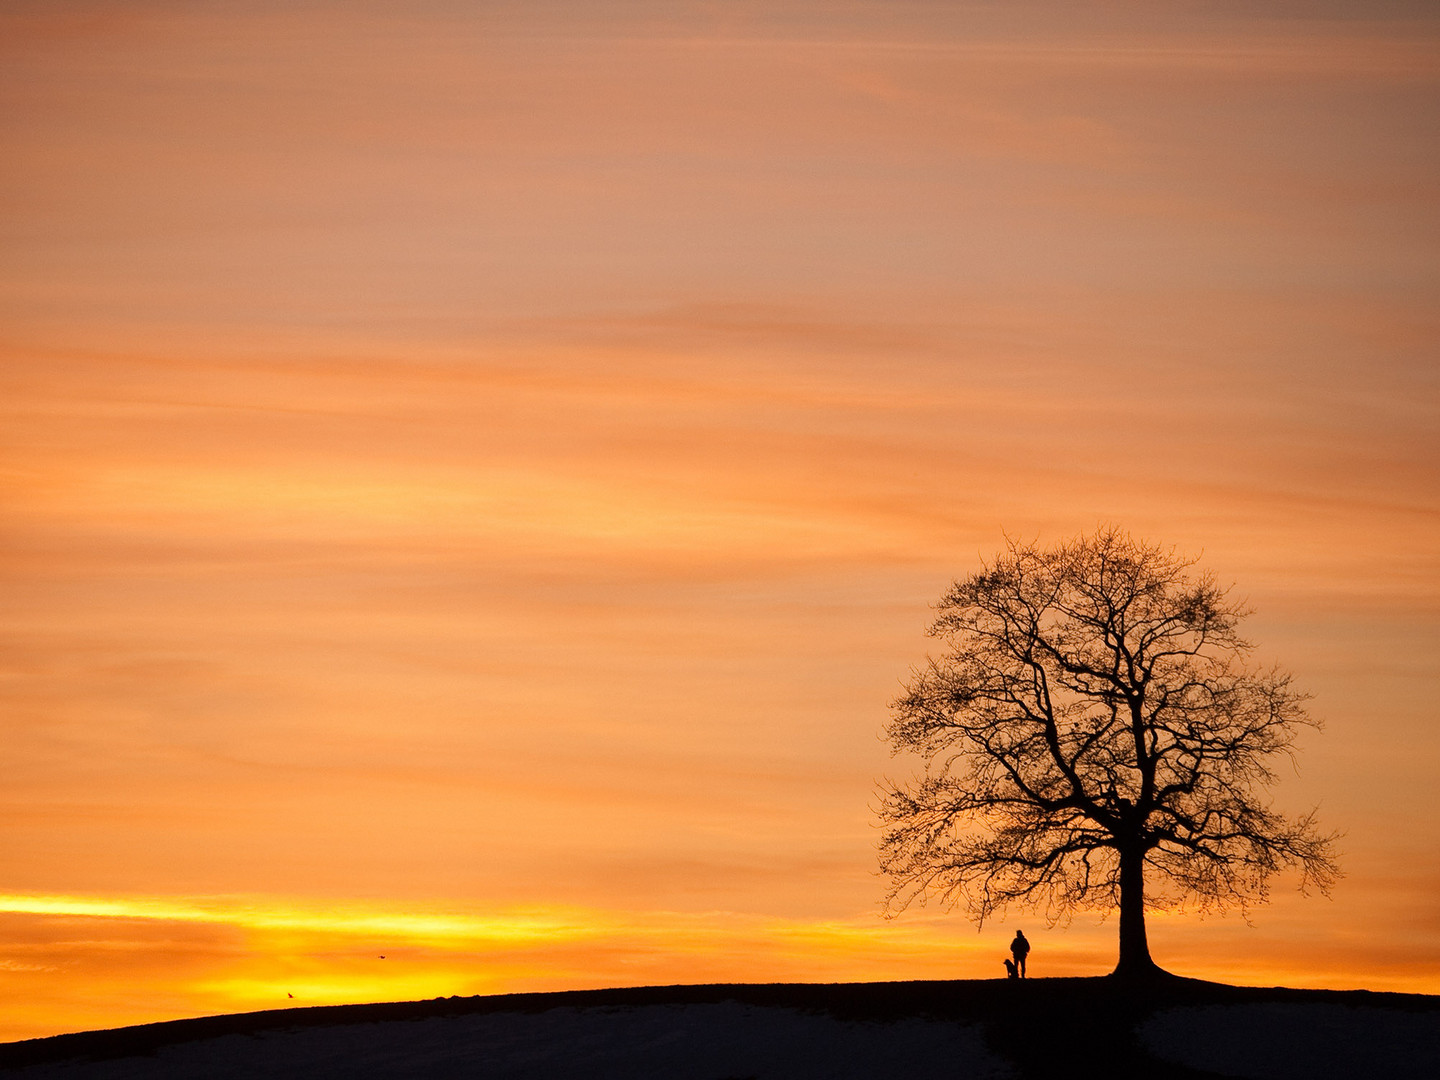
0, 976, 1440, 1080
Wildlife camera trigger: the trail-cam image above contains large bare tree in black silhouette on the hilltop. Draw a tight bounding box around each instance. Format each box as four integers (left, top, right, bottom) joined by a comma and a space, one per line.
880, 528, 1339, 976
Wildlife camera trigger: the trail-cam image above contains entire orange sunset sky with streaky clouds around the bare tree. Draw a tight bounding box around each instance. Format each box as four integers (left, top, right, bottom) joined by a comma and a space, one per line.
0, 0, 1440, 1038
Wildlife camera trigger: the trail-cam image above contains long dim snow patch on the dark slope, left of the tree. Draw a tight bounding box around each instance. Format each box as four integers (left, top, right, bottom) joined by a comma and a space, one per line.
19, 1002, 1011, 1080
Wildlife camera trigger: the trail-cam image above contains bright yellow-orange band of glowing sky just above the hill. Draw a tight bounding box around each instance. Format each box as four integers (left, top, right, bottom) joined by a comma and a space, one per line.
0, 894, 1440, 1038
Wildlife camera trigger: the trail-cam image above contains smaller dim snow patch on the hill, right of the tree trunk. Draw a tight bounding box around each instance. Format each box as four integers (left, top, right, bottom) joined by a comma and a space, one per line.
1139, 1002, 1440, 1080
